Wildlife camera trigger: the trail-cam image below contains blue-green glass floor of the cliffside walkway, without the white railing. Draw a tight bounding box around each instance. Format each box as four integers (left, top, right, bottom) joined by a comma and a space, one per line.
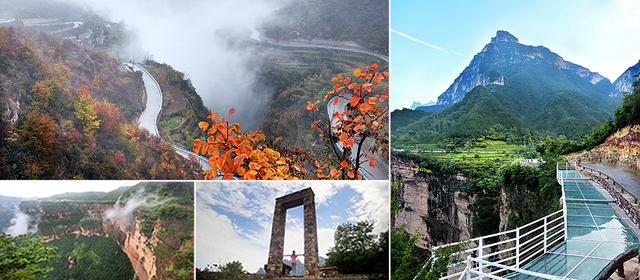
507, 170, 638, 279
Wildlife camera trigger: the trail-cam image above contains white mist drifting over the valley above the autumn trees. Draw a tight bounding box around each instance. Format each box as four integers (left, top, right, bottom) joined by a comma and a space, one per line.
59, 0, 288, 128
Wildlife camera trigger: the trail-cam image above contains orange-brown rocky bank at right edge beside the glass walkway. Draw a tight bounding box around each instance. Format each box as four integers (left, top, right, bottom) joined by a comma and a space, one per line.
579, 125, 640, 171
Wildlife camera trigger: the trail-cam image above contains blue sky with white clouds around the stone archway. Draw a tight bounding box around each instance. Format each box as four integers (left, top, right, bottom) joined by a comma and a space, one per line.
196, 181, 389, 273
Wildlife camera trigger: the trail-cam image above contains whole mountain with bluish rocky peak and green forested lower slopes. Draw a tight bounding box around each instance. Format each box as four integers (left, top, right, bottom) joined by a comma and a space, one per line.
391, 31, 621, 143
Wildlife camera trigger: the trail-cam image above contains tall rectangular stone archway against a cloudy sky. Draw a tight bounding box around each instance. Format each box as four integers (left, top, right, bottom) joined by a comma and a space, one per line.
267, 188, 319, 277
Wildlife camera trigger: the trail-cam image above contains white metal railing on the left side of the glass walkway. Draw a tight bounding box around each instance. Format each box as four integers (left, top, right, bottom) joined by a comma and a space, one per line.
424, 209, 566, 279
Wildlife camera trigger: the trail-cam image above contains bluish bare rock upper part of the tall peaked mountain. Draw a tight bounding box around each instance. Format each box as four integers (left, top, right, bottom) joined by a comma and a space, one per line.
437, 31, 613, 106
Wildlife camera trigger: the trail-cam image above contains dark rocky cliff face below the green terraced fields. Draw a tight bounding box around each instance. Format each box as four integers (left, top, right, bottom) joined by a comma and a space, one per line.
392, 159, 473, 249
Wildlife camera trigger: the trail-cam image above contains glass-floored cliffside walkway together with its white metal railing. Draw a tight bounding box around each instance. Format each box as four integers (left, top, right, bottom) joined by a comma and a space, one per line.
436, 167, 640, 280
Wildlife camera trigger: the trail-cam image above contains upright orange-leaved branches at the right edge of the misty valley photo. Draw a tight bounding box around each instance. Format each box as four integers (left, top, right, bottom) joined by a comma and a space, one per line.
307, 64, 389, 179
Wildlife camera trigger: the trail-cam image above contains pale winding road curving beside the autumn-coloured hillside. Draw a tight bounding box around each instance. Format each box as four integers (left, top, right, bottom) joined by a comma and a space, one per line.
132, 64, 211, 170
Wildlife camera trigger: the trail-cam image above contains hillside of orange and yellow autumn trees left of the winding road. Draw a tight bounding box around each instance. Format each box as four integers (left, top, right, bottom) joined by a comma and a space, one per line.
0, 28, 198, 179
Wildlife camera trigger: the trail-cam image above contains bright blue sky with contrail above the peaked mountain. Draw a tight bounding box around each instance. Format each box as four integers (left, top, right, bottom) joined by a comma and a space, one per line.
390, 0, 640, 109
